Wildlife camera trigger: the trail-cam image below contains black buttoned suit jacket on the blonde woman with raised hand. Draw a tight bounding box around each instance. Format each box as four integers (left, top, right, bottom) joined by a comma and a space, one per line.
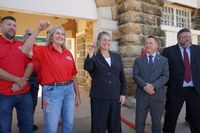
84, 52, 126, 100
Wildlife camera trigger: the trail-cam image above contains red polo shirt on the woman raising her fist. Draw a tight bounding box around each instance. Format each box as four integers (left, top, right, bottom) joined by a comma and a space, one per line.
33, 44, 77, 85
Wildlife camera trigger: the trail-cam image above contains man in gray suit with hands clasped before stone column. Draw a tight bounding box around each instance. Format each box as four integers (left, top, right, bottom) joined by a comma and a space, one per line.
133, 36, 169, 133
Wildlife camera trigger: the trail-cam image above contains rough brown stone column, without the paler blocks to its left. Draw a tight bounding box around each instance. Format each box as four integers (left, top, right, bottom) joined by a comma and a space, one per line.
115, 0, 165, 95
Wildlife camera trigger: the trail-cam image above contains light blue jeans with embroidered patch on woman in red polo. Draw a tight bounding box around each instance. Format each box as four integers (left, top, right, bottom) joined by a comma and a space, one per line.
43, 83, 75, 133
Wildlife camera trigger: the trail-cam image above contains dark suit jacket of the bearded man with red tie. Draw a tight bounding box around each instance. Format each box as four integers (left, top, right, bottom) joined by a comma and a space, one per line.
162, 44, 200, 95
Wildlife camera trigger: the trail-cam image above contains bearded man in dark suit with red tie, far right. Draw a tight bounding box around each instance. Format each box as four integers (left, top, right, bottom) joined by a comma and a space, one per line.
162, 28, 200, 133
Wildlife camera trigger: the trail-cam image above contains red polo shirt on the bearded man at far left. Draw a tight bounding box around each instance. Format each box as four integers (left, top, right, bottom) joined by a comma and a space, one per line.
0, 36, 30, 95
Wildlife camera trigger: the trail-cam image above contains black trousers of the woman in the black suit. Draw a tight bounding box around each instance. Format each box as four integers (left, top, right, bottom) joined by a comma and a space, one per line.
90, 98, 122, 133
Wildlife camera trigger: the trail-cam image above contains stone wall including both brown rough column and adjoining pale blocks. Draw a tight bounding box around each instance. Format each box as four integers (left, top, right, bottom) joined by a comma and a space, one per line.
89, 0, 165, 95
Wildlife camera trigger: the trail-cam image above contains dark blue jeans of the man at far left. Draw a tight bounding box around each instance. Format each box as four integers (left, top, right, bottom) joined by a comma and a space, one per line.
0, 92, 33, 133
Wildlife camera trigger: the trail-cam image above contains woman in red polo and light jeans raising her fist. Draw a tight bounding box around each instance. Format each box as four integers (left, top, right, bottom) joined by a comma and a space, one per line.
23, 20, 80, 133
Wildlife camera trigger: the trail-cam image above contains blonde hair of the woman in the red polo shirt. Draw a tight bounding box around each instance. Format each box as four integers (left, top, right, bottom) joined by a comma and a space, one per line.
46, 25, 66, 48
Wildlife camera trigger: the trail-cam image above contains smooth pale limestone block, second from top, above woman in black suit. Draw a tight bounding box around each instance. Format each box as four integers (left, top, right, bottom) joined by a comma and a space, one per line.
97, 7, 112, 20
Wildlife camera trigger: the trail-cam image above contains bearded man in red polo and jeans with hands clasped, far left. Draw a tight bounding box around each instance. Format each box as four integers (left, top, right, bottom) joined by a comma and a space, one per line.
0, 16, 33, 133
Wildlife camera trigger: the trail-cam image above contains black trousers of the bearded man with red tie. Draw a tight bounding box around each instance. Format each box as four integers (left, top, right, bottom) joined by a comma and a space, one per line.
163, 87, 200, 133
